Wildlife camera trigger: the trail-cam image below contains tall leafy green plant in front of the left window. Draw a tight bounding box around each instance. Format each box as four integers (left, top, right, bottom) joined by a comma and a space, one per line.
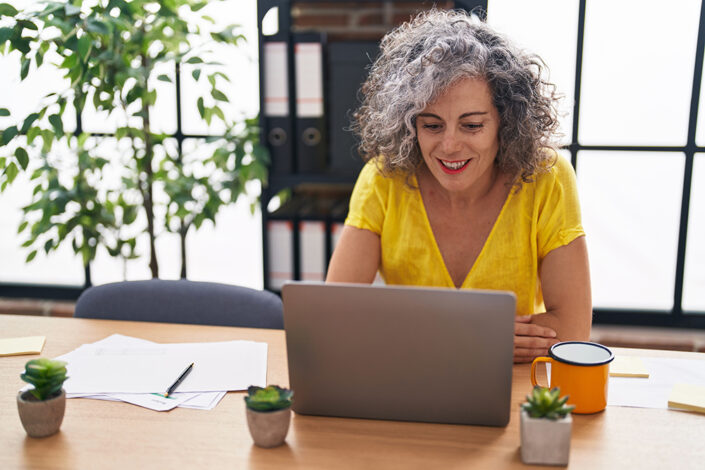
0, 0, 268, 285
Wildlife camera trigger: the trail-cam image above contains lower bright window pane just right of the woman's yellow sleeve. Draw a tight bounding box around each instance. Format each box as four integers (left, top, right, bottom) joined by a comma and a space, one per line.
578, 151, 685, 310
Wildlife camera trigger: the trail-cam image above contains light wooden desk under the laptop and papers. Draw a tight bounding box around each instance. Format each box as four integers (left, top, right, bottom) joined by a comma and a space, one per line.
0, 315, 705, 470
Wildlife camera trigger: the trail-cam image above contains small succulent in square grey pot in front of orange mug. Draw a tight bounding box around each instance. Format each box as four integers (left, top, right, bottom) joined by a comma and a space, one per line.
520, 386, 575, 465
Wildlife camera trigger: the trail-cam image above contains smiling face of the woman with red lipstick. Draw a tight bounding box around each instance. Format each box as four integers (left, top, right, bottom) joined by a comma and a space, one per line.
416, 78, 499, 200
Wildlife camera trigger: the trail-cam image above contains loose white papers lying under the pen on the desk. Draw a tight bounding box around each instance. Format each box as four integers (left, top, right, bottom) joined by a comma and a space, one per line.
44, 334, 267, 411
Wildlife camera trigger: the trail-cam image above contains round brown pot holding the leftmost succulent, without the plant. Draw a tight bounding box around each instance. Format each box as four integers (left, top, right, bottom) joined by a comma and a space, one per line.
17, 388, 66, 437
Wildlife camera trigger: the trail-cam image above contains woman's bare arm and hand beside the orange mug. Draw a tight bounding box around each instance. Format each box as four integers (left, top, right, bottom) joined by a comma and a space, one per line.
514, 236, 592, 362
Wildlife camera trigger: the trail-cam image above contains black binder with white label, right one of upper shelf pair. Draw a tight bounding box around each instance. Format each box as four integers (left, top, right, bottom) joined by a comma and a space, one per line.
293, 33, 328, 173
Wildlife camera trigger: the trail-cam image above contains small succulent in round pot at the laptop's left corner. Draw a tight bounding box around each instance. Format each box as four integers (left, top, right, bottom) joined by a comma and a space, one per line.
245, 385, 294, 448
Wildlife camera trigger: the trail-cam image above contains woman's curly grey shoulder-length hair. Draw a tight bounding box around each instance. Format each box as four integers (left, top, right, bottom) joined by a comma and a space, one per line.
352, 9, 558, 185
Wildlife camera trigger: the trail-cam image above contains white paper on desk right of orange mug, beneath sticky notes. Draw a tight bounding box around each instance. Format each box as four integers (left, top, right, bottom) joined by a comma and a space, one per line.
607, 357, 705, 409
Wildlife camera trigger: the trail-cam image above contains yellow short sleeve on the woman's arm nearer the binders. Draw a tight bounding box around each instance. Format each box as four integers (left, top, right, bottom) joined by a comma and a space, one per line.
345, 160, 389, 235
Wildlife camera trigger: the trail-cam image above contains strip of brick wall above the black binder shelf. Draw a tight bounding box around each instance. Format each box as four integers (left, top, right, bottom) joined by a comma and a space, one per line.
291, 1, 454, 41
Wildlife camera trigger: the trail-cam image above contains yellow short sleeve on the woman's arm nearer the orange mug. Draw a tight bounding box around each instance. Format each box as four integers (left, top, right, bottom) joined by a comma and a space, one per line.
536, 155, 585, 259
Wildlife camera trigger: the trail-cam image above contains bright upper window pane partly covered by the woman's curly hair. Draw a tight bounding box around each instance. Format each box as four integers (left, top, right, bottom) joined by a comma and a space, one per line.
487, 0, 578, 144
